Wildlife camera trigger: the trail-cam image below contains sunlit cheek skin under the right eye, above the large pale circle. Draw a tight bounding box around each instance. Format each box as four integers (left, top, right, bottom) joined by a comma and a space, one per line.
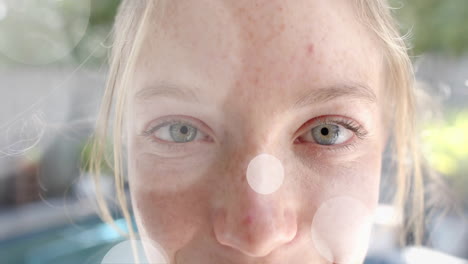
290, 143, 382, 205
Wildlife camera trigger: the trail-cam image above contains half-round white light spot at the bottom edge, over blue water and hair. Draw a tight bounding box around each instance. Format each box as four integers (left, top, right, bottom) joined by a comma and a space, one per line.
101, 240, 169, 264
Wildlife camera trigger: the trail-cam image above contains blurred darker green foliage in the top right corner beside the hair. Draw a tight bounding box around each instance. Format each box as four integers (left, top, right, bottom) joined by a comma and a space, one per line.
390, 0, 468, 56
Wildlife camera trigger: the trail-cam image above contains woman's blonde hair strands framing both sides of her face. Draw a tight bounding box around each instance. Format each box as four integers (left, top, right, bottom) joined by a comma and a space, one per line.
89, 0, 424, 249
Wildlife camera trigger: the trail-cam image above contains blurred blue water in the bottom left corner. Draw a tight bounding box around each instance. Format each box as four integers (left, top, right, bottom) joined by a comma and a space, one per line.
0, 217, 126, 264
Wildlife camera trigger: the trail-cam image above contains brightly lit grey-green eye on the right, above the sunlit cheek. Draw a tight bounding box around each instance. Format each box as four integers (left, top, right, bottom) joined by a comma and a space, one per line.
300, 124, 354, 145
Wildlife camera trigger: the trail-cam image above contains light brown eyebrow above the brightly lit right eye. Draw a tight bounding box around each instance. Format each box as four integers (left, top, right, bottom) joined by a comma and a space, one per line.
293, 84, 377, 109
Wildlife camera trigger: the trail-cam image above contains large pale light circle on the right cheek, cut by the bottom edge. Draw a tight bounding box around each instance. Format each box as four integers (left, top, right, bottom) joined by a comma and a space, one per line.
311, 196, 372, 264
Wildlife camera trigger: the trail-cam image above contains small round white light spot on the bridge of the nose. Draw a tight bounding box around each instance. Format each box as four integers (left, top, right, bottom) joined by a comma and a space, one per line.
247, 154, 284, 194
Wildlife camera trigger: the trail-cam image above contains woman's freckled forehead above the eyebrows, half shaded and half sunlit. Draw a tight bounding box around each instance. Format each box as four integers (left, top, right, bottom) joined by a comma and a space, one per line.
132, 0, 382, 107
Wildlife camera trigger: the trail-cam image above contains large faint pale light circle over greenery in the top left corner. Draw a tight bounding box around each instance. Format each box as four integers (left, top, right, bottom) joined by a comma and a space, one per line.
0, 0, 91, 65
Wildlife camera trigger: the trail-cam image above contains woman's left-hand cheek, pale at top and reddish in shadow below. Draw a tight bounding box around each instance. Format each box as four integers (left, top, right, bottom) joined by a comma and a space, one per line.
129, 154, 213, 256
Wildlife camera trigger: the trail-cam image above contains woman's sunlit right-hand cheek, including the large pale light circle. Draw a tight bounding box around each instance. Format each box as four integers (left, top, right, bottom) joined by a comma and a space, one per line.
292, 152, 381, 263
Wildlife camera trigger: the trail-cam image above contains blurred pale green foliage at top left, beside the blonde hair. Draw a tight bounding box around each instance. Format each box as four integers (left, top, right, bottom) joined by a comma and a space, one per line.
0, 0, 121, 66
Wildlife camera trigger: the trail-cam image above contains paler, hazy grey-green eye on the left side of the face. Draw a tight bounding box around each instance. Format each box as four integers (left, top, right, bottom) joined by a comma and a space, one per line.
147, 121, 205, 143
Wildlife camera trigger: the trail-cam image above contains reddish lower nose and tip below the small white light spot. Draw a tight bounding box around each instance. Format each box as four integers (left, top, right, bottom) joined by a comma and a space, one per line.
213, 162, 297, 257
